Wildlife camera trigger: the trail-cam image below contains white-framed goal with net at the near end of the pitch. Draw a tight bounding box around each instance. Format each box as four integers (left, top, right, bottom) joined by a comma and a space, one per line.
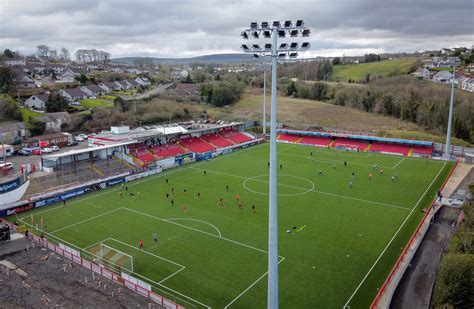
89, 243, 133, 273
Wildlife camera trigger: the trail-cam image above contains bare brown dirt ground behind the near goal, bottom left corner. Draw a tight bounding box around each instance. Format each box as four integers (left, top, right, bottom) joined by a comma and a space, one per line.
0, 247, 158, 308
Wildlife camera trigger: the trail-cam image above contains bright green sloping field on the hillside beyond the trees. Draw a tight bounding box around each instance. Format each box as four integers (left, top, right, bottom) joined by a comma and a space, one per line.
333, 58, 416, 81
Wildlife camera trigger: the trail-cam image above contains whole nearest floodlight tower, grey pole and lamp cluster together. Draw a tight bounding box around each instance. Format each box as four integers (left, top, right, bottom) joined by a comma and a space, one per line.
241, 20, 310, 309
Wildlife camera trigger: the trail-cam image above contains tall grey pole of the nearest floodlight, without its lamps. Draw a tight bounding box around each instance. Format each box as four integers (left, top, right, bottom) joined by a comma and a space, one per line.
267, 25, 278, 309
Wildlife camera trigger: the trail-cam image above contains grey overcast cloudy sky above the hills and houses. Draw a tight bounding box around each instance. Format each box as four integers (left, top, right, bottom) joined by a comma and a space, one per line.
0, 0, 474, 57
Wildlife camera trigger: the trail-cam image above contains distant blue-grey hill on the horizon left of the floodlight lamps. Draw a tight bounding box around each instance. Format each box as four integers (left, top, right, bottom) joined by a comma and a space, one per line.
111, 54, 256, 64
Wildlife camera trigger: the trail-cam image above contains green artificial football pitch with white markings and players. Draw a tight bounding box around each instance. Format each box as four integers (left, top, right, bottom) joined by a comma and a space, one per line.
10, 144, 453, 308
